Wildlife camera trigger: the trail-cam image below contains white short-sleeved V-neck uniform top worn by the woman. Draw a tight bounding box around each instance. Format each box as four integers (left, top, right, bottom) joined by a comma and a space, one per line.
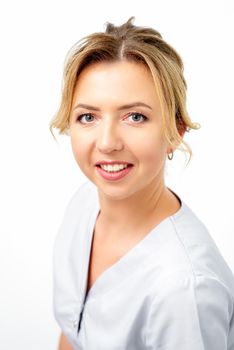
53, 181, 234, 350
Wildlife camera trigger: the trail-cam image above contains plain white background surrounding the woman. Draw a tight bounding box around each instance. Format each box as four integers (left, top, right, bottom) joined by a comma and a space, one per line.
0, 0, 234, 350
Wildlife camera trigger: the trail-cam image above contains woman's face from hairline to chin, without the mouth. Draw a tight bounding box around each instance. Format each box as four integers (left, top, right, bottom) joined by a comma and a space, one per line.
70, 61, 169, 199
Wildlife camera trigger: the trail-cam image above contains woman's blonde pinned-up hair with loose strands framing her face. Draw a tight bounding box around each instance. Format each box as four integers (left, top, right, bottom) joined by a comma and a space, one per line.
50, 16, 200, 161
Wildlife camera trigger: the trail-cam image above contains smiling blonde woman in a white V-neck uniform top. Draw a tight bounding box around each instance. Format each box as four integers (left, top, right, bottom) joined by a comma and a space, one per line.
51, 17, 234, 350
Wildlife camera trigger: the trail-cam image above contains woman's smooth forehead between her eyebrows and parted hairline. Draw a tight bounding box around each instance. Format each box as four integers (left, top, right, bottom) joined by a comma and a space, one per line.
73, 61, 159, 109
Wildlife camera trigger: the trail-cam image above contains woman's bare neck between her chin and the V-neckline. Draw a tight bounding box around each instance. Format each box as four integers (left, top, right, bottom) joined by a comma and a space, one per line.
95, 181, 173, 237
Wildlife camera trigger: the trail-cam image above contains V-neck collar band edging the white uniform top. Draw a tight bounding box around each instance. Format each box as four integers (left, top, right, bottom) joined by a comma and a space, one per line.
80, 188, 187, 304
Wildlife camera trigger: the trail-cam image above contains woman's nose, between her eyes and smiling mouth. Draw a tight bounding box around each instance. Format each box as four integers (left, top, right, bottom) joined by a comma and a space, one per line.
96, 121, 123, 153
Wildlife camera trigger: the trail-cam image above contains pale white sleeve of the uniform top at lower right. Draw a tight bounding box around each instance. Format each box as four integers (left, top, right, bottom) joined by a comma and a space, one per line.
146, 275, 233, 350
